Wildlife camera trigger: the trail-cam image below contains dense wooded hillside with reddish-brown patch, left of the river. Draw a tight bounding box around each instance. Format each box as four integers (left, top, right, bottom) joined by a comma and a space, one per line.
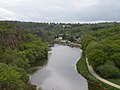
0, 22, 48, 90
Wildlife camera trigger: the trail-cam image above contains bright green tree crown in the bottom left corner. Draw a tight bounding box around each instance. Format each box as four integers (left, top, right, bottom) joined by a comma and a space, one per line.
0, 63, 25, 90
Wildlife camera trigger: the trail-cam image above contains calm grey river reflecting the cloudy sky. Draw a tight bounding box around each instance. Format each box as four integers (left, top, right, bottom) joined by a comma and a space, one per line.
30, 44, 88, 90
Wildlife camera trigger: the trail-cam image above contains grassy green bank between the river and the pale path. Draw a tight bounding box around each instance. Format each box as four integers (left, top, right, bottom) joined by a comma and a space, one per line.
77, 52, 119, 90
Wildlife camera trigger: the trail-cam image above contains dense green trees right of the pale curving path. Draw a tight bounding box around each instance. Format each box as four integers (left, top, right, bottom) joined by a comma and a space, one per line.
82, 24, 120, 78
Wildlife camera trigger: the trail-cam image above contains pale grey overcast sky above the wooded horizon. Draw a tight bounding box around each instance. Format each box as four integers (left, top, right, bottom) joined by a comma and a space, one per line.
0, 0, 120, 22
